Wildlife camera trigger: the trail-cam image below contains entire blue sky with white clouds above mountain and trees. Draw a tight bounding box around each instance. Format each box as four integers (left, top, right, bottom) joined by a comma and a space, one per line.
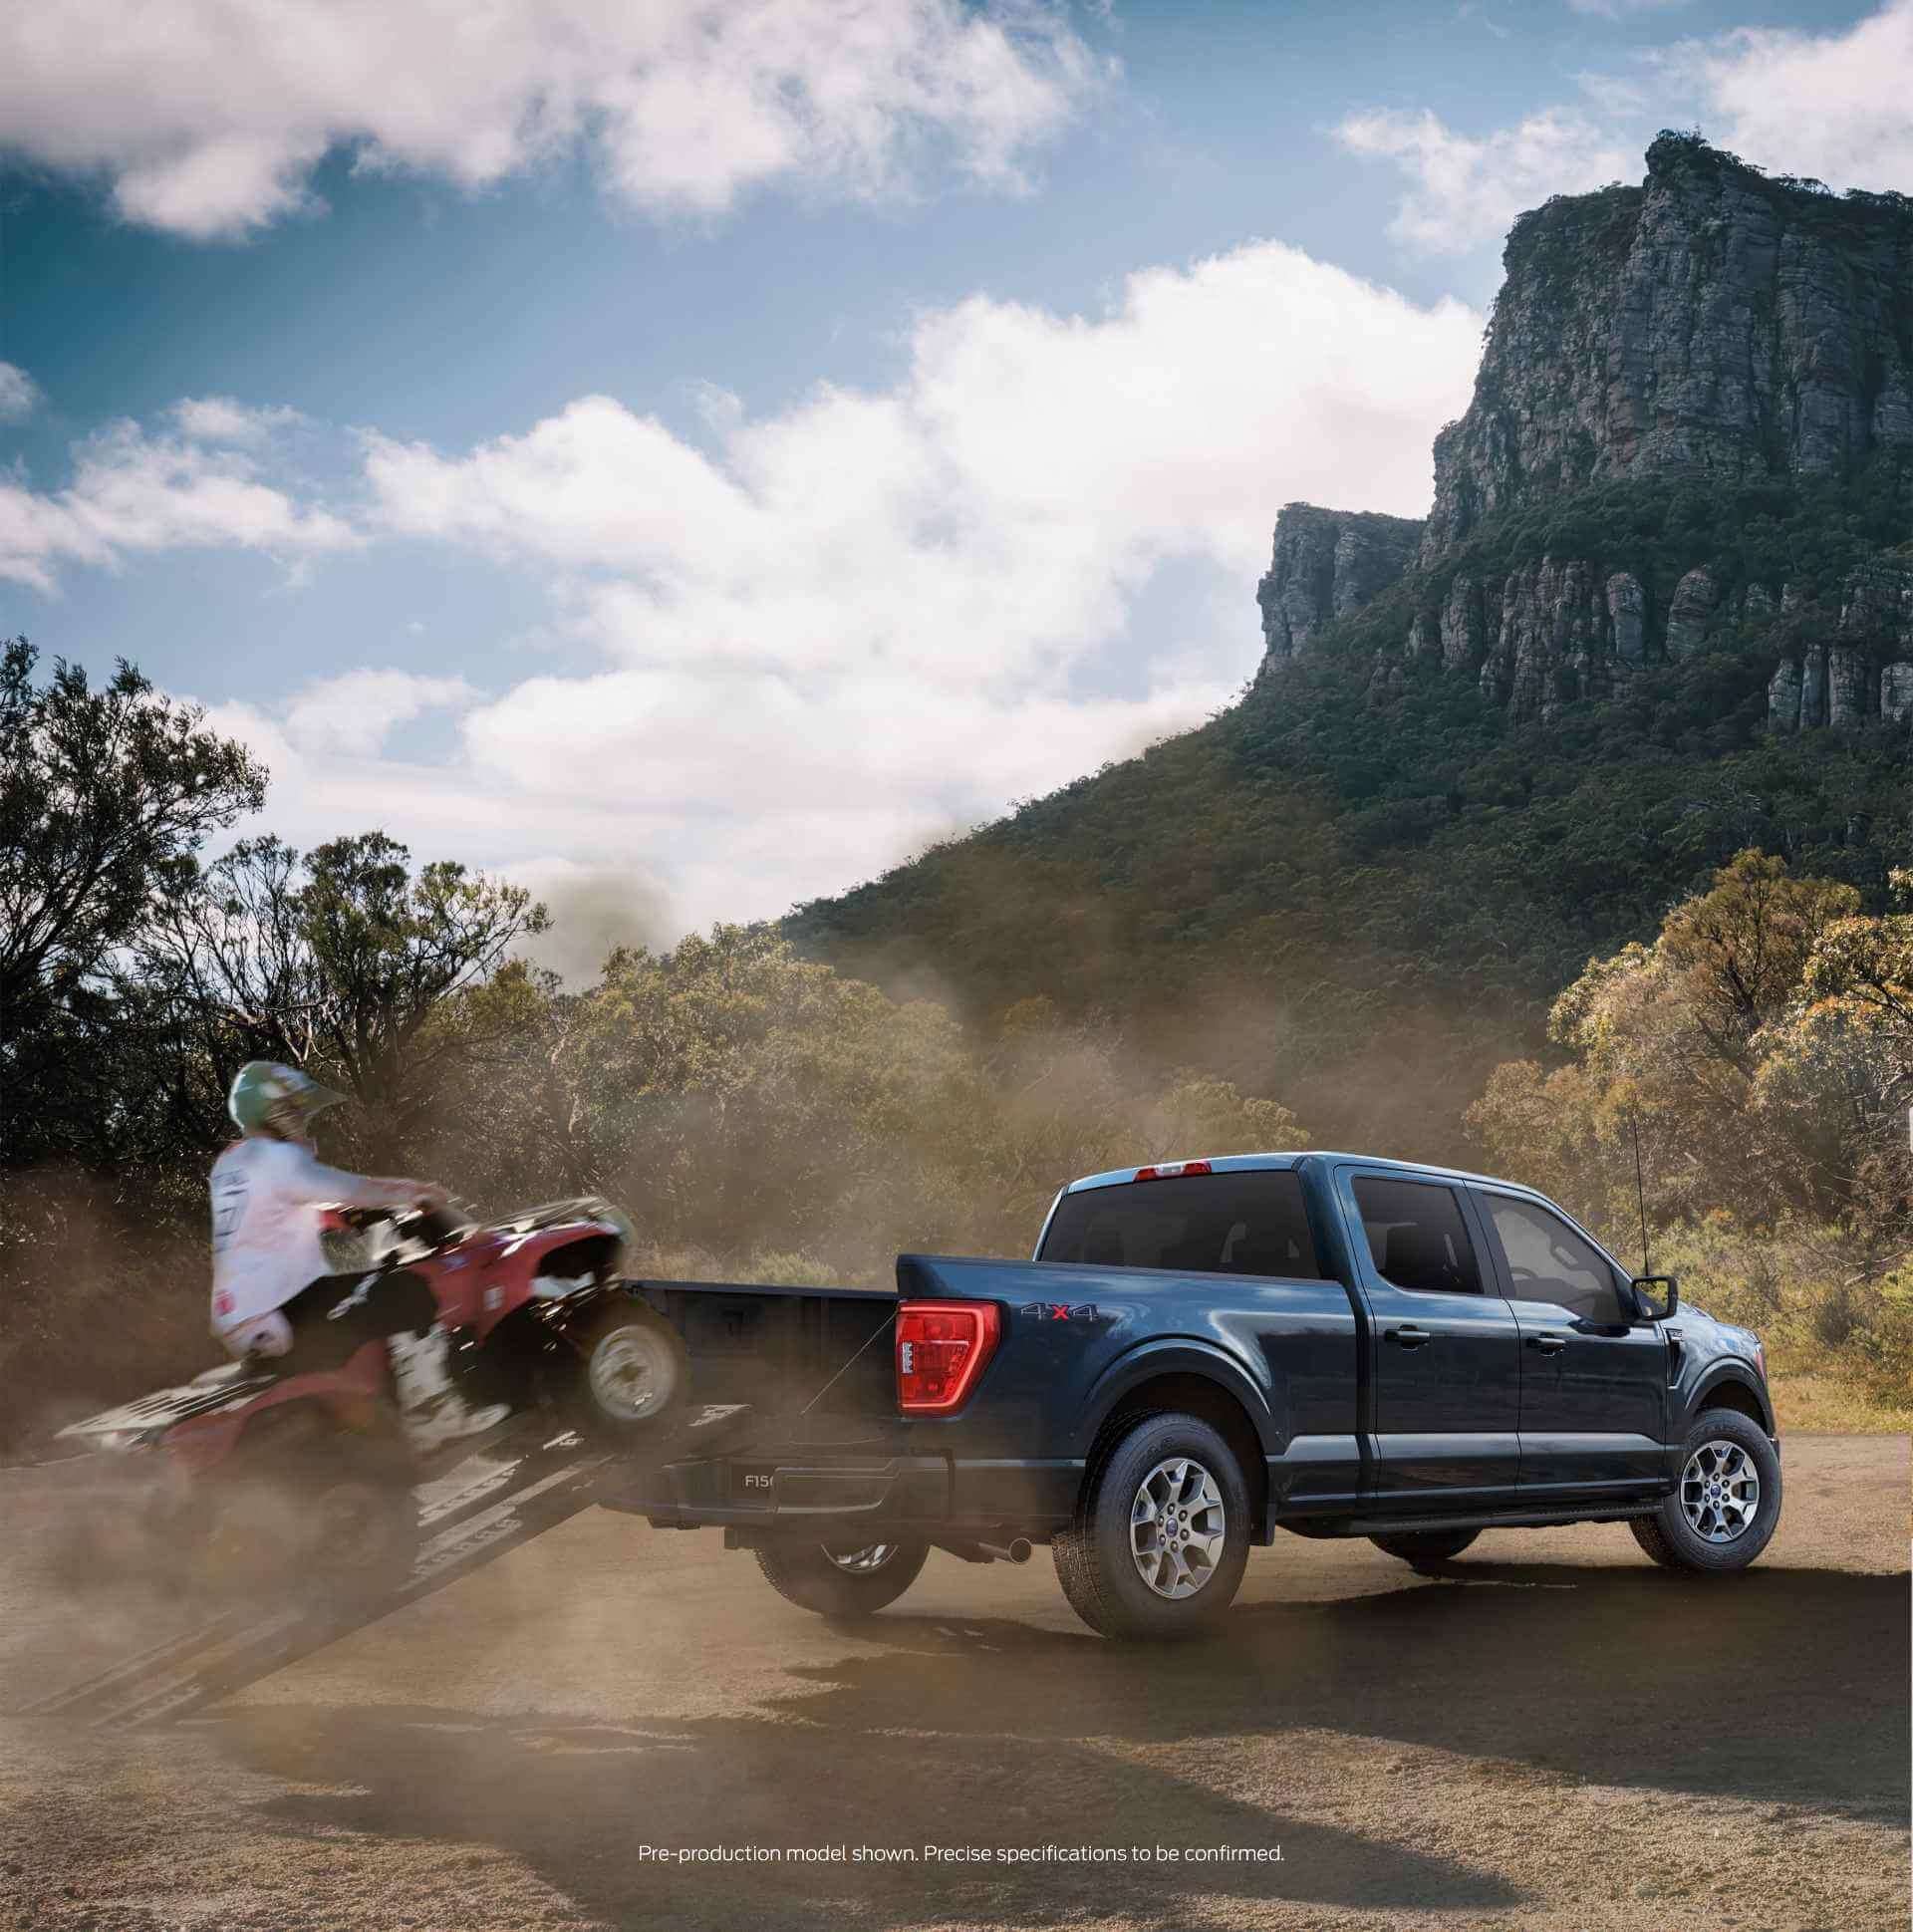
0, 0, 1913, 966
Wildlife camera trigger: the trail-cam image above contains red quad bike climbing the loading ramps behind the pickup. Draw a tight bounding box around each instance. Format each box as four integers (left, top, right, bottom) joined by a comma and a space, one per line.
60, 1200, 689, 1592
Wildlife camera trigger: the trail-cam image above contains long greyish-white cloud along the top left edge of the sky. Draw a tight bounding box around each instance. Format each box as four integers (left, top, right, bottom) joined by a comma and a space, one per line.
0, 0, 1100, 237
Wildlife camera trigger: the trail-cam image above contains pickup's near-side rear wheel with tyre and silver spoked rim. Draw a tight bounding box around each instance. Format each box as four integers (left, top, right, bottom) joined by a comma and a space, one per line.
1051, 1414, 1248, 1640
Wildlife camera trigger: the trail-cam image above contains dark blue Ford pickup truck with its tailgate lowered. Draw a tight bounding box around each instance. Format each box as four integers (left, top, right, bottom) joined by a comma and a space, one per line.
621, 1154, 1779, 1636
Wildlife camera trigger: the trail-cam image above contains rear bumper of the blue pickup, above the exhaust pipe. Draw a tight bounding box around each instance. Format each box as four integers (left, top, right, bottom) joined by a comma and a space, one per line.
603, 1445, 1084, 1541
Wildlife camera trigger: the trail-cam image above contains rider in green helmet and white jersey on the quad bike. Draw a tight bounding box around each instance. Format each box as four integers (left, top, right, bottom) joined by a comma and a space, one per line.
210, 1061, 510, 1449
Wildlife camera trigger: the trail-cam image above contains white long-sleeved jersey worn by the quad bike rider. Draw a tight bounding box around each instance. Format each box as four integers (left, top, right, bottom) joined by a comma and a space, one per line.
210, 1136, 391, 1335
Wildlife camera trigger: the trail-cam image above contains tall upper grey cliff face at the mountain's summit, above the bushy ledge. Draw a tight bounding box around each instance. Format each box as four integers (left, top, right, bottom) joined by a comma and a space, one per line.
1422, 136, 1913, 562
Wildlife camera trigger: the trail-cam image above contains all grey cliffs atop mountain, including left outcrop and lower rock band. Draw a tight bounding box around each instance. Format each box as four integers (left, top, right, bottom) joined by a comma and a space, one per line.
1258, 136, 1913, 730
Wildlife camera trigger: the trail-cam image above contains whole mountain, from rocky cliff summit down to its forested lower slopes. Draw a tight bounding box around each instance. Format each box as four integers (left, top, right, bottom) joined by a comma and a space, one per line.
784, 136, 1913, 1156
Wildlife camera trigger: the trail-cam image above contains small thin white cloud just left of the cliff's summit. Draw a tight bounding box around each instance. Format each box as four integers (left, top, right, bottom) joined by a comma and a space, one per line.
1335, 109, 1641, 255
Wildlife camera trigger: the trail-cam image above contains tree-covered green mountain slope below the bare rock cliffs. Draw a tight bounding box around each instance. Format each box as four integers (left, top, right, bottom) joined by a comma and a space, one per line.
786, 485, 1913, 1154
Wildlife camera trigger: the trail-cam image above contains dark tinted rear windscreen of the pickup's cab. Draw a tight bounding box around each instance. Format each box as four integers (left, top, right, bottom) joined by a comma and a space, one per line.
1039, 1169, 1322, 1281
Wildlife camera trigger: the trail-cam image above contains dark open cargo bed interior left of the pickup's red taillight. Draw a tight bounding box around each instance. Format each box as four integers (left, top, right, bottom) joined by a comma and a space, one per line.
630, 1281, 897, 1426
